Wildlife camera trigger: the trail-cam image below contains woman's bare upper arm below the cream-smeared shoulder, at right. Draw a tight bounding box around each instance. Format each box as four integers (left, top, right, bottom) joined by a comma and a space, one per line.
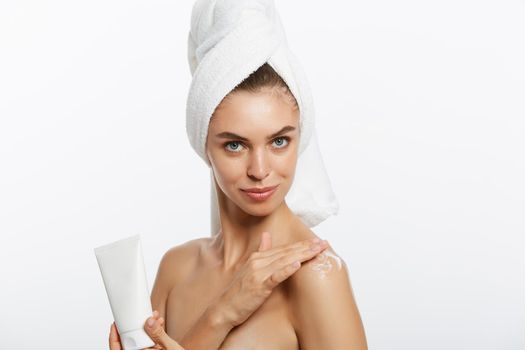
290, 248, 368, 350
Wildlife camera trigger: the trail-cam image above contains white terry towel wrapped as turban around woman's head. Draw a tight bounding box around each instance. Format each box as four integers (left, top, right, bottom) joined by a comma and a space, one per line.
186, 0, 339, 234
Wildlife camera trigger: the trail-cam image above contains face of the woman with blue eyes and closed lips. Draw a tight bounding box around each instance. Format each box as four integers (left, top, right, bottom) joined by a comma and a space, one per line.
206, 90, 300, 216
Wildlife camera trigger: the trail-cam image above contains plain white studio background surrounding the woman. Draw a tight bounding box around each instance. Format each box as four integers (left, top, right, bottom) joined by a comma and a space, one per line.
0, 0, 525, 350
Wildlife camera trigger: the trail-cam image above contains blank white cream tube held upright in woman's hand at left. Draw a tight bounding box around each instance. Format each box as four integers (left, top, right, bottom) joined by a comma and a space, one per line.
95, 235, 155, 350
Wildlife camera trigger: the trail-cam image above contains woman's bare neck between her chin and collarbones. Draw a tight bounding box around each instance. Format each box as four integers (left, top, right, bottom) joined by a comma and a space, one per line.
212, 190, 298, 272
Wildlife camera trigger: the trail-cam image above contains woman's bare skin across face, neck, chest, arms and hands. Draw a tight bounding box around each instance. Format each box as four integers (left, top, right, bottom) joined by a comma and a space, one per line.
110, 89, 367, 350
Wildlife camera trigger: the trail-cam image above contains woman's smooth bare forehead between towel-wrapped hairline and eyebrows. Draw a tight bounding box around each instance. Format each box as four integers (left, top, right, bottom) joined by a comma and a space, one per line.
209, 91, 299, 134
